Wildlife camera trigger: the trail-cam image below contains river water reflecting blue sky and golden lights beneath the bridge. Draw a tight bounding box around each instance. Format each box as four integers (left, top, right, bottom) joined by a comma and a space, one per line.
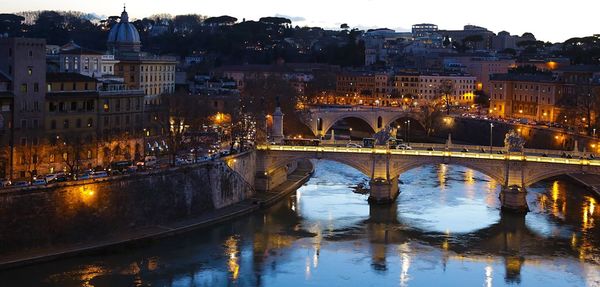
0, 161, 600, 286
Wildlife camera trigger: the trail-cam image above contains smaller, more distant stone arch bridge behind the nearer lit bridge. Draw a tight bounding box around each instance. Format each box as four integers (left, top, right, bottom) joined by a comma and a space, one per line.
304, 106, 424, 137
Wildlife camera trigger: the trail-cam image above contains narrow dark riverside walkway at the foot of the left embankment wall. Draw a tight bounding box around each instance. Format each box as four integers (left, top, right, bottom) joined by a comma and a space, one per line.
0, 161, 314, 269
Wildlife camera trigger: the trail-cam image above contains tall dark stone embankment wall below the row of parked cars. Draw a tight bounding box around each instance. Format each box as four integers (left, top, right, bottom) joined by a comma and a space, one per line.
0, 152, 256, 254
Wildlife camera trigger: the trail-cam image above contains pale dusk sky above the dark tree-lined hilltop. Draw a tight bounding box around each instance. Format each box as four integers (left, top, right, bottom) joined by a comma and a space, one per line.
1, 0, 600, 42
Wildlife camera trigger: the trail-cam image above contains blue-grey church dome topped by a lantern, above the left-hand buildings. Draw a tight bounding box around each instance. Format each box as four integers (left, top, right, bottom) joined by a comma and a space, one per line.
106, 7, 142, 55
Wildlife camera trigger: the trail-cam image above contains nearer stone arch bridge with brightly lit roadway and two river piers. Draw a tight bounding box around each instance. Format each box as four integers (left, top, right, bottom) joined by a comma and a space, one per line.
257, 143, 600, 212
